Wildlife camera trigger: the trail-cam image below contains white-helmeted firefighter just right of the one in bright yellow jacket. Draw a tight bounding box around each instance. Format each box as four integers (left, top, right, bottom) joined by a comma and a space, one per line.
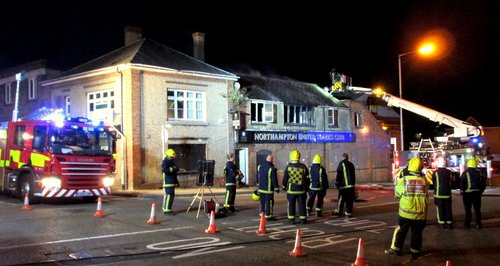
432, 157, 453, 229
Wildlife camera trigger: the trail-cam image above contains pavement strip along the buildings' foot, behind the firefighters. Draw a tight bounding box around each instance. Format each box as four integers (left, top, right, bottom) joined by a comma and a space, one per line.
113, 183, 500, 197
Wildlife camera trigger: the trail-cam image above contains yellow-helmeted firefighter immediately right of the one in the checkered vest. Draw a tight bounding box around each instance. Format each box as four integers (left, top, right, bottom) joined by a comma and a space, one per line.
306, 154, 328, 217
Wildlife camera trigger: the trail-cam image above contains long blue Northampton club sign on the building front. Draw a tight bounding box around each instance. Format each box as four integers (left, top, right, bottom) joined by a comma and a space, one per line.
239, 131, 355, 143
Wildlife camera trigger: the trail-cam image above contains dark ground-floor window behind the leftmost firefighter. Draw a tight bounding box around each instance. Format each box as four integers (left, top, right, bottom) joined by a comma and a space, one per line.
168, 144, 206, 172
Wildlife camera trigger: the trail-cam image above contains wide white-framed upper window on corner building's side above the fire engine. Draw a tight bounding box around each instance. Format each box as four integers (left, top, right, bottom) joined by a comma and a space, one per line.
88, 90, 115, 122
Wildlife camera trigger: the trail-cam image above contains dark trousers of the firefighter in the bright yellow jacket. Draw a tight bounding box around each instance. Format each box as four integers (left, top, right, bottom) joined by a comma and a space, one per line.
391, 216, 426, 254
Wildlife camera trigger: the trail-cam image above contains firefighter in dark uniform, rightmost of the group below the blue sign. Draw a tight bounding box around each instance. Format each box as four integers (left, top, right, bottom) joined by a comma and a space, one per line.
332, 153, 356, 218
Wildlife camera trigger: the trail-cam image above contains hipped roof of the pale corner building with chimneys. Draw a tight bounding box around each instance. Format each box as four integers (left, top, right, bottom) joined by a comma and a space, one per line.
60, 38, 237, 79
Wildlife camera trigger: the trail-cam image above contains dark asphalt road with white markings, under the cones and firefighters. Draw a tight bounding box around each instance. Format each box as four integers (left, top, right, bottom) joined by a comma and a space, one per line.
0, 189, 500, 266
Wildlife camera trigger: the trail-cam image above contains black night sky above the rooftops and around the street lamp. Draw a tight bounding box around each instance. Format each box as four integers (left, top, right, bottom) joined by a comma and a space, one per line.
0, 0, 500, 143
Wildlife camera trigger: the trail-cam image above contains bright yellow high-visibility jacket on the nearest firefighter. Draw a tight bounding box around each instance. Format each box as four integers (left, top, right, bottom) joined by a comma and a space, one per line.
394, 172, 429, 220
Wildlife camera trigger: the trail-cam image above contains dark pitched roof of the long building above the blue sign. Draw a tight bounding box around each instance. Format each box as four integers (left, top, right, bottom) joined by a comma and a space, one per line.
239, 74, 347, 107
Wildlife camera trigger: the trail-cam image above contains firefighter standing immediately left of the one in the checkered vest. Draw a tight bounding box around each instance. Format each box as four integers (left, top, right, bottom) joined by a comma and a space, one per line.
257, 154, 280, 221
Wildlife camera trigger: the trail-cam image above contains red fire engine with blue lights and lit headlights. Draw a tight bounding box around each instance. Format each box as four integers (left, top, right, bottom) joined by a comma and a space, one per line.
0, 112, 115, 201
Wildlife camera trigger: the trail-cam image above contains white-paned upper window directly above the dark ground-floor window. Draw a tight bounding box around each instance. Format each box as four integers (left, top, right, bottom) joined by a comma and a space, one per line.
167, 89, 205, 121
